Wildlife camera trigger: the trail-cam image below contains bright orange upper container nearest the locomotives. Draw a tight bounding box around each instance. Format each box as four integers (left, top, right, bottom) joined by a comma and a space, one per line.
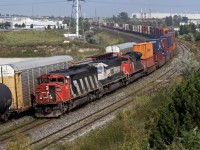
133, 43, 153, 59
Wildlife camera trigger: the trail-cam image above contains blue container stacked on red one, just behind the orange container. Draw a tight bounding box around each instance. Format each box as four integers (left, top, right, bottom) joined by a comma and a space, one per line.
147, 39, 165, 67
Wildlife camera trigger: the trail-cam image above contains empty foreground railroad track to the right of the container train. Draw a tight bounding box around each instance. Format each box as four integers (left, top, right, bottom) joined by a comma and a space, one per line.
28, 44, 185, 149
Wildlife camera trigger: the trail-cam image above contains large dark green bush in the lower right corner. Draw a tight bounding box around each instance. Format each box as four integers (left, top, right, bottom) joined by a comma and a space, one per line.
149, 69, 200, 149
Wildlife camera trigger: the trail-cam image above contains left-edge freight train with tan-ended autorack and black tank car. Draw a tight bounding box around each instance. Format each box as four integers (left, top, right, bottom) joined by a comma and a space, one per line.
0, 56, 73, 121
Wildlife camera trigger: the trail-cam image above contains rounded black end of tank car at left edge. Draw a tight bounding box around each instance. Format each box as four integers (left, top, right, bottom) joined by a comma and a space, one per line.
0, 83, 12, 114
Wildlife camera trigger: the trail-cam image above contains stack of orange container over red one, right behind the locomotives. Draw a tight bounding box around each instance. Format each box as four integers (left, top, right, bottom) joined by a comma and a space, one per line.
133, 43, 156, 74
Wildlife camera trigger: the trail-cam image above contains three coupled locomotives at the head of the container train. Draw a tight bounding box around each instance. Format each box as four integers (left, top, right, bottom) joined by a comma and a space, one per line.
34, 52, 144, 117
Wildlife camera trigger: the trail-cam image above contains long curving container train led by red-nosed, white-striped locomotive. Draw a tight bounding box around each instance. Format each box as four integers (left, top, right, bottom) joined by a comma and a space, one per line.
34, 24, 176, 117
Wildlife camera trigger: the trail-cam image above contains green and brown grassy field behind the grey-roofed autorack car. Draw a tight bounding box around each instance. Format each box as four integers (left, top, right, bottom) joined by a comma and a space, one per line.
0, 30, 122, 59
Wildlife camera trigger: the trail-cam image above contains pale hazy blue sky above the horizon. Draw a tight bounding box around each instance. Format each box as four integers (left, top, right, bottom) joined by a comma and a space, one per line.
0, 0, 200, 17
